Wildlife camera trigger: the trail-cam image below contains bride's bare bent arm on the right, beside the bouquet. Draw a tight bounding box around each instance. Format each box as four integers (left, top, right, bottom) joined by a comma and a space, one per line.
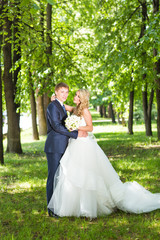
78, 108, 93, 132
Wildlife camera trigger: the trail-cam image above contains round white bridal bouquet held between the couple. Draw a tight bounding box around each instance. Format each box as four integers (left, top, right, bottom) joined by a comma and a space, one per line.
65, 115, 81, 131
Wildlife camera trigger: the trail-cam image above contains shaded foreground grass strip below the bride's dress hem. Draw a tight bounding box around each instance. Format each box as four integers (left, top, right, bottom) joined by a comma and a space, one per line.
0, 187, 159, 240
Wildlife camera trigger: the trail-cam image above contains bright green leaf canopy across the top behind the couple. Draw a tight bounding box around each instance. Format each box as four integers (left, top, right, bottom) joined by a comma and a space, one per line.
0, 0, 160, 129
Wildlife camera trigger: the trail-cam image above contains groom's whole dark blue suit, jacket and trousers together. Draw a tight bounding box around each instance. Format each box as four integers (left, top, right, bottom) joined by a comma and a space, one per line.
44, 100, 78, 208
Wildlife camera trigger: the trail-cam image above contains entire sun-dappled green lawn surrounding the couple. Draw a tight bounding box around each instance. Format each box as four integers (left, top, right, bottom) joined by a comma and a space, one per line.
0, 111, 160, 240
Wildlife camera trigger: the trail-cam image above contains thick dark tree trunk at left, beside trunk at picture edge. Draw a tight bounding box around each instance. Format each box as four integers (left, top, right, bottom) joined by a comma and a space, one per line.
3, 6, 22, 153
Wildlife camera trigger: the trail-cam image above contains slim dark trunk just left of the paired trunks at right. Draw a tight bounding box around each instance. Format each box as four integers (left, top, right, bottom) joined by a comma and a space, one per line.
128, 90, 134, 134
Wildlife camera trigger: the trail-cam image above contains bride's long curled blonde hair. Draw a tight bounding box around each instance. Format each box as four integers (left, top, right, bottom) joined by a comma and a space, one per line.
74, 89, 89, 117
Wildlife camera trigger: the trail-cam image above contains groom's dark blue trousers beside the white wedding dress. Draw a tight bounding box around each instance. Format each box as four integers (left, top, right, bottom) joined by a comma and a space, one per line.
46, 153, 63, 205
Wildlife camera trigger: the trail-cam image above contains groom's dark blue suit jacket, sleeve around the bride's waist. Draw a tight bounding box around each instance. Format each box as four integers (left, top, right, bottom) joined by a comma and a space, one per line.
44, 100, 78, 153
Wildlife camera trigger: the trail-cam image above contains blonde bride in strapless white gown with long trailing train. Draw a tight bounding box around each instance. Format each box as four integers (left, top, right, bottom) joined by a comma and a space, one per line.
48, 89, 160, 218
